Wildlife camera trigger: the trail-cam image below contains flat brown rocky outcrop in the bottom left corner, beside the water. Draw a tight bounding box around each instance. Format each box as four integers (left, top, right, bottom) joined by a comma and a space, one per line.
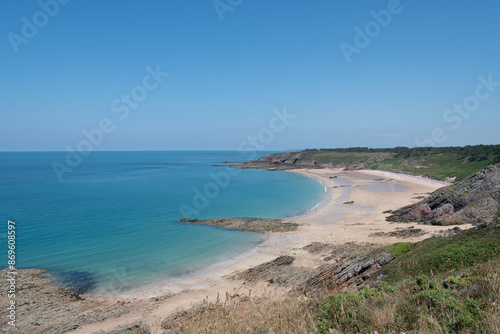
0, 269, 137, 334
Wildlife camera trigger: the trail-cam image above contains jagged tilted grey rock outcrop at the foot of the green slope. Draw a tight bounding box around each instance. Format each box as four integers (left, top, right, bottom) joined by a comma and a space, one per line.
304, 250, 395, 291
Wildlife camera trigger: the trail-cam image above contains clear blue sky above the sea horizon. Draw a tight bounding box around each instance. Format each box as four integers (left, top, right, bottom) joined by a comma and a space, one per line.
0, 0, 500, 151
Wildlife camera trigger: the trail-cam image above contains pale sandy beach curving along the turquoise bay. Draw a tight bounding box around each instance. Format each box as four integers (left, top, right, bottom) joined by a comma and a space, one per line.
19, 169, 469, 333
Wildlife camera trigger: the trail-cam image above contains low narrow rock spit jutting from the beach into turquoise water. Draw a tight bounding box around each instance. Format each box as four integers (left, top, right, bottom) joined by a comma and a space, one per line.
185, 218, 299, 232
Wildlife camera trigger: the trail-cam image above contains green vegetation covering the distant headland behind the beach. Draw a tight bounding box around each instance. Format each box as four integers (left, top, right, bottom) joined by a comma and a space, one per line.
282, 145, 500, 181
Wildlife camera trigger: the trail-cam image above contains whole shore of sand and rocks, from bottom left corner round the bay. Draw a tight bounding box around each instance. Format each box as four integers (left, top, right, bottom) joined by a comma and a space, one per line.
5, 168, 470, 334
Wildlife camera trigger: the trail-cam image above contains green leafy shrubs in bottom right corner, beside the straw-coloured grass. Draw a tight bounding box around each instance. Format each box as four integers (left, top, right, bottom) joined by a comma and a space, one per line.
316, 261, 500, 333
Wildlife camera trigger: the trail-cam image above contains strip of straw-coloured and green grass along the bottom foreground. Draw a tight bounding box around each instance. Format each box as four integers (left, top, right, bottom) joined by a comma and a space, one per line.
157, 259, 500, 334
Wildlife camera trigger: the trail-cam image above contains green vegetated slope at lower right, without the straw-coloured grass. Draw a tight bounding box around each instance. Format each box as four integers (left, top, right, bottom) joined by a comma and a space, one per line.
316, 224, 500, 333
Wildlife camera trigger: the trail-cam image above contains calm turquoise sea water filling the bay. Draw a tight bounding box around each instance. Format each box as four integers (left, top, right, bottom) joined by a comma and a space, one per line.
0, 151, 324, 291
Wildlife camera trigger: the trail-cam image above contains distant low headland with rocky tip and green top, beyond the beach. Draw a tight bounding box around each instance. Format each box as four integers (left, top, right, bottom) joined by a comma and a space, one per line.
234, 145, 500, 182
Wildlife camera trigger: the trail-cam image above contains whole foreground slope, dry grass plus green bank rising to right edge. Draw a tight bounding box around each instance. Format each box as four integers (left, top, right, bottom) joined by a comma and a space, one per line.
155, 222, 500, 334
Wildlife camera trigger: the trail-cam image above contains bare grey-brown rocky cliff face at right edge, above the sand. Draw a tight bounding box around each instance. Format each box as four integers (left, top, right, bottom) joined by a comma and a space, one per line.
387, 164, 500, 225
